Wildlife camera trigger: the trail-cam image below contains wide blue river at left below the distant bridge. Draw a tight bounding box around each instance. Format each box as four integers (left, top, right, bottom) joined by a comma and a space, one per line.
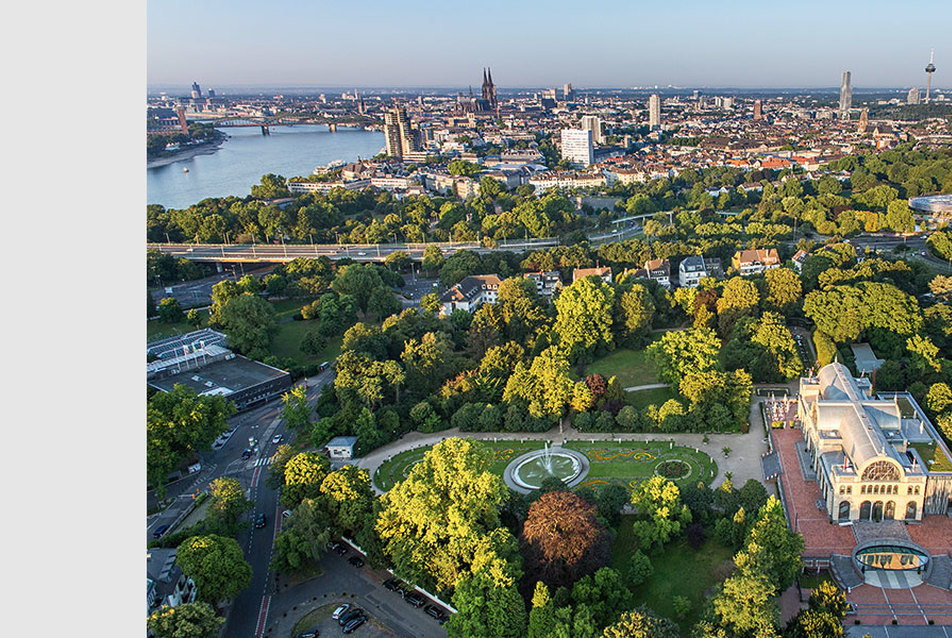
146, 125, 384, 208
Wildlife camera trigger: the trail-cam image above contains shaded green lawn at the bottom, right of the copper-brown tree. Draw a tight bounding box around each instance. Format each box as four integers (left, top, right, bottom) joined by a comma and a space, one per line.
611, 516, 733, 636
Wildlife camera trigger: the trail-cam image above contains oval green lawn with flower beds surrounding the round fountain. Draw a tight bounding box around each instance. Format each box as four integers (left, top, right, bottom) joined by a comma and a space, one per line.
373, 441, 717, 491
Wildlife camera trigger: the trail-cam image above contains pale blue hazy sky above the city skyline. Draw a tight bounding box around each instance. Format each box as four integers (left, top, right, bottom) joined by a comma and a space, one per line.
147, 0, 952, 88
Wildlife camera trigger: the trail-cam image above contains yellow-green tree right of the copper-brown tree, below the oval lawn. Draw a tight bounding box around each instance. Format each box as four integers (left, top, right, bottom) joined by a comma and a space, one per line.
631, 476, 691, 551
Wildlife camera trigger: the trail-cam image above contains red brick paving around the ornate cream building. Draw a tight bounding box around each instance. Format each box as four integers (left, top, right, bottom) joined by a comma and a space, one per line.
771, 429, 952, 625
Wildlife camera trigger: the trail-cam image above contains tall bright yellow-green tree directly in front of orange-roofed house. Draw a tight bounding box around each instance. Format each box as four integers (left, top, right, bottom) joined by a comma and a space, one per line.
553, 277, 615, 361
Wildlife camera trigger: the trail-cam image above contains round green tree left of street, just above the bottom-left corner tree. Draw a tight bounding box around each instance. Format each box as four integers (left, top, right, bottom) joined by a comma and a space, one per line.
175, 534, 251, 605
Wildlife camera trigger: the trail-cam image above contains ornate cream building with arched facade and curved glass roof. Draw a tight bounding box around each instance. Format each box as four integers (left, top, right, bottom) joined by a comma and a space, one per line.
797, 362, 952, 521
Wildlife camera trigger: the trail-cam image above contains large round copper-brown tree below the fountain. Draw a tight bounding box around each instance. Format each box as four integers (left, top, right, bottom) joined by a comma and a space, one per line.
521, 492, 609, 587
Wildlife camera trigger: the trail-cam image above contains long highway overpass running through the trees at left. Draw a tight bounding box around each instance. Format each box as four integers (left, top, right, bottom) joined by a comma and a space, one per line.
146, 238, 559, 263
